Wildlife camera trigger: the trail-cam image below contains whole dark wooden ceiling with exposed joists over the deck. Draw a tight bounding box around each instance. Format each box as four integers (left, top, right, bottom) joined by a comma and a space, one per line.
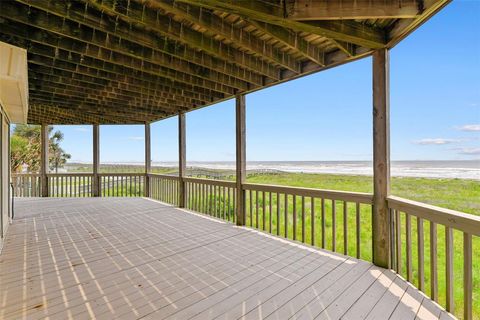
0, 0, 449, 124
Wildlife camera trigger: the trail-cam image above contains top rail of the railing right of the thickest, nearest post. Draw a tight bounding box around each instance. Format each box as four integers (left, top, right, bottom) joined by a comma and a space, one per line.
387, 196, 480, 236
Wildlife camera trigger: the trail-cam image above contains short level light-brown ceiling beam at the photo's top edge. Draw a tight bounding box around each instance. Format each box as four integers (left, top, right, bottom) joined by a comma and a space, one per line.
286, 0, 423, 21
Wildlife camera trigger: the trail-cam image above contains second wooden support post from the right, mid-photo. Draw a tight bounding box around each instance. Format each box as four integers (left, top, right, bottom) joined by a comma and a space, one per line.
235, 95, 247, 226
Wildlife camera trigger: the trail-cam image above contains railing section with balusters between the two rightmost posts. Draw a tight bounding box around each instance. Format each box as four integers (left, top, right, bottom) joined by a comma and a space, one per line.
243, 183, 372, 260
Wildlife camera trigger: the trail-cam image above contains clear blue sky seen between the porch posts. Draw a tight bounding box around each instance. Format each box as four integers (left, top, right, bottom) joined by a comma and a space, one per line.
54, 0, 480, 162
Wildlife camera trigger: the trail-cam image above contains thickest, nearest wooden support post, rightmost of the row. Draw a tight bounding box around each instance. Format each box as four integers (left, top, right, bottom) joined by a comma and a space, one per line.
373, 49, 391, 268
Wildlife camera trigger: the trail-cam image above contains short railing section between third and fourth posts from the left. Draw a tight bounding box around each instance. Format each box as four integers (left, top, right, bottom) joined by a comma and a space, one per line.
148, 173, 180, 206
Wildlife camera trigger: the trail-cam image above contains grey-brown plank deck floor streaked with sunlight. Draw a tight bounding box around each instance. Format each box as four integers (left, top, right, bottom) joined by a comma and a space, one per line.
0, 198, 451, 319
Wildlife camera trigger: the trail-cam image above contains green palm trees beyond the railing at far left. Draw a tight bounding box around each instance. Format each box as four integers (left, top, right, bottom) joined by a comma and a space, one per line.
11, 125, 71, 172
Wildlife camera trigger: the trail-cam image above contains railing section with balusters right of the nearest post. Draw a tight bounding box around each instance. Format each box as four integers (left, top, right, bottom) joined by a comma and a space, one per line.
388, 196, 480, 319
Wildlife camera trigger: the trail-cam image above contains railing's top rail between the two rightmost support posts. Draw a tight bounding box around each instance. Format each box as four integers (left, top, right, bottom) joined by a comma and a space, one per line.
243, 183, 373, 204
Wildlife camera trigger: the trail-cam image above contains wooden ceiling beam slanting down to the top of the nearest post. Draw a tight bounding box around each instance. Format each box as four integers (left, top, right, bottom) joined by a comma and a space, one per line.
177, 0, 386, 49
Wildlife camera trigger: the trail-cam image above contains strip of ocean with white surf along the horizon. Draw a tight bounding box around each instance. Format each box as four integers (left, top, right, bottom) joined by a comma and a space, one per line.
70, 160, 480, 180
